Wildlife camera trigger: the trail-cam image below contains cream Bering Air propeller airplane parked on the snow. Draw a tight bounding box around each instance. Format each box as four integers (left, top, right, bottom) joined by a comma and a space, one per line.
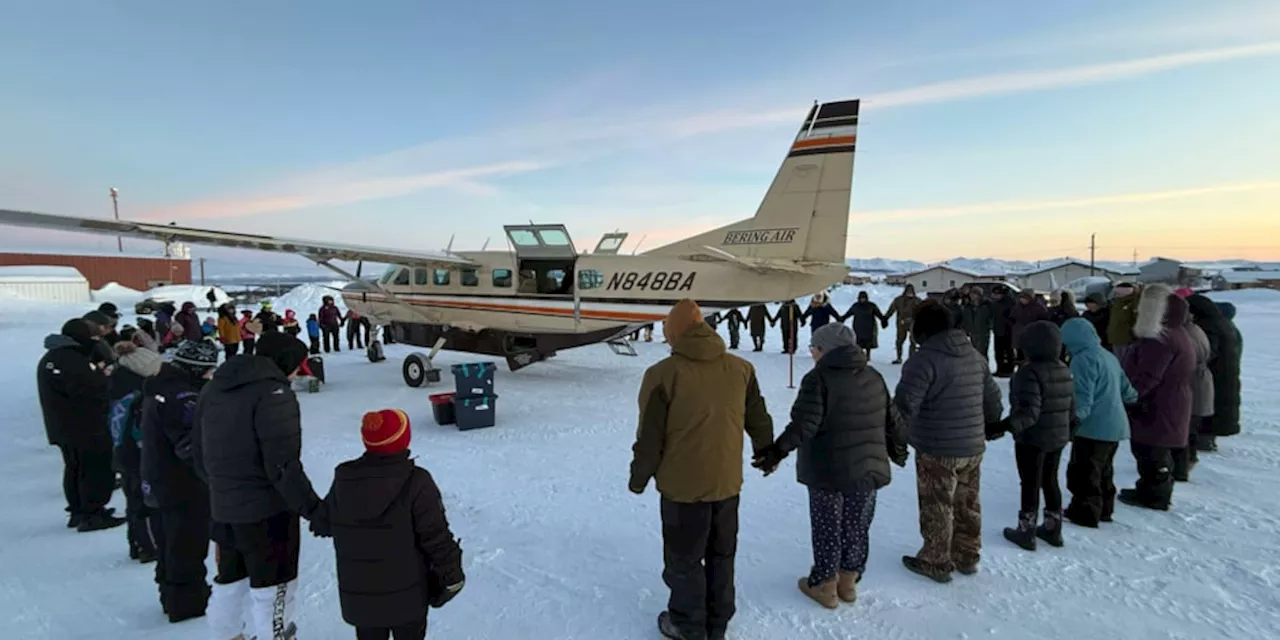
0, 100, 859, 387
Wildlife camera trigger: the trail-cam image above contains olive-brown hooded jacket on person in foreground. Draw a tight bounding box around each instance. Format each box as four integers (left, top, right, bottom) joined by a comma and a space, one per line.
630, 323, 773, 503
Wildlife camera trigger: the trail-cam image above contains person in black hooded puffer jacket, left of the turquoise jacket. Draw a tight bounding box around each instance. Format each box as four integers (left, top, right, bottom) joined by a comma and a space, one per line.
987, 320, 1079, 552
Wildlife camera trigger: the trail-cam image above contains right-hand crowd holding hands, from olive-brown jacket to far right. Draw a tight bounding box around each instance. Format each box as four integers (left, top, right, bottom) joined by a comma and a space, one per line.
628, 283, 1243, 640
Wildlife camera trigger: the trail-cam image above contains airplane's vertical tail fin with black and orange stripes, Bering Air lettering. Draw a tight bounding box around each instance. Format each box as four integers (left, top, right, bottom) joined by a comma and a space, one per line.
645, 100, 859, 262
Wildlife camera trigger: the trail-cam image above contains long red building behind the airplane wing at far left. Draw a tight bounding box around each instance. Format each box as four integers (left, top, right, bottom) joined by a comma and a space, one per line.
0, 253, 191, 291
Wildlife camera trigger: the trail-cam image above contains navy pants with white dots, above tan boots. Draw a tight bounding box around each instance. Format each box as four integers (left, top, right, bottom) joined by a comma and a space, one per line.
809, 488, 876, 586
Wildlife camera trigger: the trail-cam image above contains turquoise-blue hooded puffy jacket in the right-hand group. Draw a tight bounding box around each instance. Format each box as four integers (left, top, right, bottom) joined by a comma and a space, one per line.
1062, 317, 1138, 442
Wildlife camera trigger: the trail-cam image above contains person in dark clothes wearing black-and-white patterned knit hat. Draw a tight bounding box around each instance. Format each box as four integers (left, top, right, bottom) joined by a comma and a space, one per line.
142, 340, 219, 622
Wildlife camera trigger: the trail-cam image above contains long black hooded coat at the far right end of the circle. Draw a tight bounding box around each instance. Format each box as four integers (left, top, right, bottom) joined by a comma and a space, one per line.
1187, 294, 1242, 435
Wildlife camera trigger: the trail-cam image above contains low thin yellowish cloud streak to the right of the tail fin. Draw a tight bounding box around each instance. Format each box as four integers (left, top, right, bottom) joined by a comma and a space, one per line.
851, 180, 1280, 223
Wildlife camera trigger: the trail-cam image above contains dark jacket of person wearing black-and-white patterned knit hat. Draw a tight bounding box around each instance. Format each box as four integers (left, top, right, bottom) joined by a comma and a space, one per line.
141, 364, 209, 508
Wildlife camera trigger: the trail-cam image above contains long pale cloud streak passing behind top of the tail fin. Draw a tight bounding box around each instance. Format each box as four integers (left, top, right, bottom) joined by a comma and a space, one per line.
143, 41, 1280, 220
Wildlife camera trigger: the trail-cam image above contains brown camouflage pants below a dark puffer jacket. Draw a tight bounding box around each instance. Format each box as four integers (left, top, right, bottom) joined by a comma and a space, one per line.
915, 453, 982, 573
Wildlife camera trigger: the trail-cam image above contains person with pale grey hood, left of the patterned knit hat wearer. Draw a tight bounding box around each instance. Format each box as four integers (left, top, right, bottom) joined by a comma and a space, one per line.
110, 339, 164, 564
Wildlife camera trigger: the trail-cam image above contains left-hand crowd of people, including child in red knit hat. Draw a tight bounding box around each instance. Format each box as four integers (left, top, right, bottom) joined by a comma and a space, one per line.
37, 298, 465, 640
